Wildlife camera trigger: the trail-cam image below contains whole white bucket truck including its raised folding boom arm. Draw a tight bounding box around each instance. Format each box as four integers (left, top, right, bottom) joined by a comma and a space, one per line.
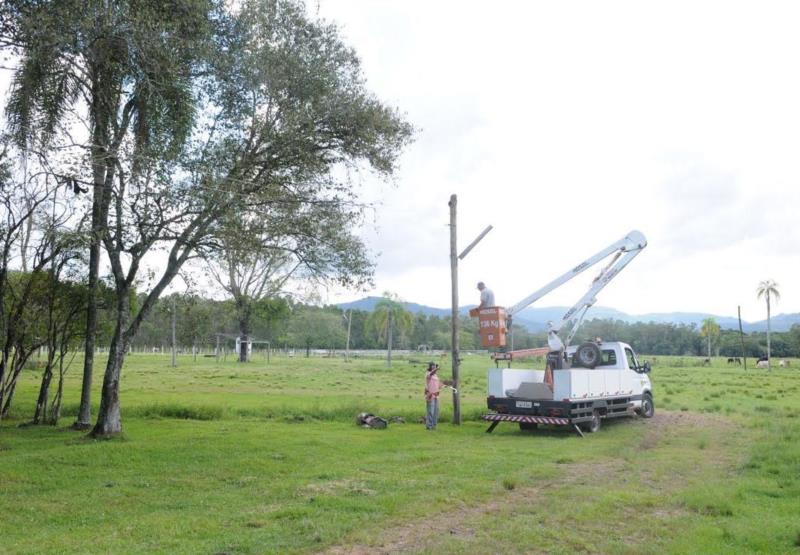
481, 231, 654, 435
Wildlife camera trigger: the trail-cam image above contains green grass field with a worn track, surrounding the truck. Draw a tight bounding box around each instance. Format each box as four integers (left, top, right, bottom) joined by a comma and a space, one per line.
0, 355, 800, 554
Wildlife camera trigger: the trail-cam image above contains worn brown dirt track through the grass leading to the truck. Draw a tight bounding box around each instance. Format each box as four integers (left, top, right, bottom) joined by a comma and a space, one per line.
324, 411, 742, 555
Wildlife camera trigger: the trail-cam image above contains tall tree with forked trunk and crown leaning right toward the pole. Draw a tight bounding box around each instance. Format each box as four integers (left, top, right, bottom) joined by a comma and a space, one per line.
87, 0, 412, 436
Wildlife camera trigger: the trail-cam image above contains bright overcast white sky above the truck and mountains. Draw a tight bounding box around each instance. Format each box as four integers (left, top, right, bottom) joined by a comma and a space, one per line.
316, 0, 800, 320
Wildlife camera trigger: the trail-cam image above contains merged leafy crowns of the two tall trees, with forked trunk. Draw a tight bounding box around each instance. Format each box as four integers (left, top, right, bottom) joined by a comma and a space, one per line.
0, 0, 413, 436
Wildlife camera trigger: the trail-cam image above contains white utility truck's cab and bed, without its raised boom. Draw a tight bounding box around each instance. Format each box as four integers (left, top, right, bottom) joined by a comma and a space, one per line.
483, 341, 655, 435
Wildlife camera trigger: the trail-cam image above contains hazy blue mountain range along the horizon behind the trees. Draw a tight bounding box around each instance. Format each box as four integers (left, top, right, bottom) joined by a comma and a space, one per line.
337, 297, 800, 333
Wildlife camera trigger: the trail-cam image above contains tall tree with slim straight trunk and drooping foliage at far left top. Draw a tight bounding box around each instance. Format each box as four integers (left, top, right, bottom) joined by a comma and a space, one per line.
0, 0, 216, 428
